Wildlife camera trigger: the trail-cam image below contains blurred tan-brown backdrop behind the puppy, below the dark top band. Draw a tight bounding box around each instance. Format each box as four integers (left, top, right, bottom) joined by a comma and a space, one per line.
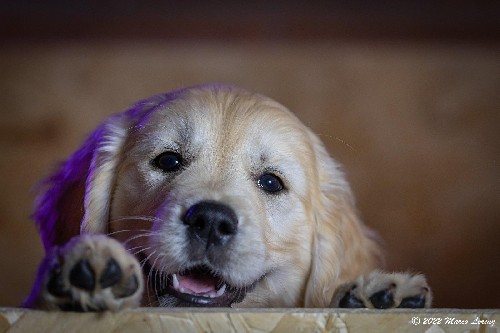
0, 41, 500, 308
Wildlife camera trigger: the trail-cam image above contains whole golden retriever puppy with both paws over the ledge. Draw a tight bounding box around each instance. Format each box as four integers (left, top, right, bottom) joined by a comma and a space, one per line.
25, 85, 431, 311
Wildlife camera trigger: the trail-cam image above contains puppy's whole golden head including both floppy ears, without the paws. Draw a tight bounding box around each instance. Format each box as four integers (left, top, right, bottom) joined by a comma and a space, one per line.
39, 85, 375, 307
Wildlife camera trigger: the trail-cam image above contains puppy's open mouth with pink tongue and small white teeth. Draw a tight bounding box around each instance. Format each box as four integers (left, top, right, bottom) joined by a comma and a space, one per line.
143, 256, 258, 307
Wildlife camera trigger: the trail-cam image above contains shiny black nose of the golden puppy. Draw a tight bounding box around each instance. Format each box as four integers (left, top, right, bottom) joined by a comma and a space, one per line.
183, 201, 238, 247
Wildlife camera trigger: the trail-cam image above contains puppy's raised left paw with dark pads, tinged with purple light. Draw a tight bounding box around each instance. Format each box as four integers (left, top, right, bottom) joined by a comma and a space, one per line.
25, 235, 144, 311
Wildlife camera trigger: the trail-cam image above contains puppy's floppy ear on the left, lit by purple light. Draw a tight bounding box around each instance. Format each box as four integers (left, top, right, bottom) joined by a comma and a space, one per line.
33, 94, 168, 250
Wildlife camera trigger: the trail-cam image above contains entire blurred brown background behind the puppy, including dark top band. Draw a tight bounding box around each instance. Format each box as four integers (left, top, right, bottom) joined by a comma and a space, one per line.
0, 0, 500, 308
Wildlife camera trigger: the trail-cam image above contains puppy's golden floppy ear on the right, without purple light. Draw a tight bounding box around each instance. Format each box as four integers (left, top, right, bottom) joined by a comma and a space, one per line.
304, 133, 381, 307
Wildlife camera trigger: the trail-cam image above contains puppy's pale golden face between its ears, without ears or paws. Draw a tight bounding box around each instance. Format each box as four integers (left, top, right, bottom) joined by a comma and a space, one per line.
109, 89, 319, 306
